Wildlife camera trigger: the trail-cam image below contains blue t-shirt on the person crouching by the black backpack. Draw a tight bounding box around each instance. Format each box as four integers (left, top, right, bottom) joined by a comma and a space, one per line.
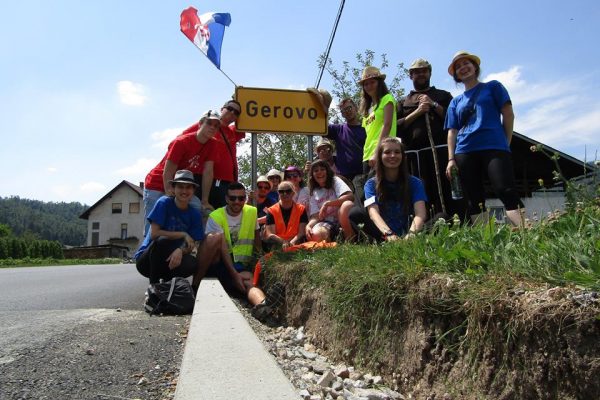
133, 196, 204, 260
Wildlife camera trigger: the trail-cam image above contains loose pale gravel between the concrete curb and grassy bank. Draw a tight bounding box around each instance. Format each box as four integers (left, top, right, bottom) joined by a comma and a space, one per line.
236, 301, 432, 400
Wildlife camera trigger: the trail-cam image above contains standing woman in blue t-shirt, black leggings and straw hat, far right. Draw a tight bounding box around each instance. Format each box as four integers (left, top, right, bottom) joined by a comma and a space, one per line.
444, 51, 525, 226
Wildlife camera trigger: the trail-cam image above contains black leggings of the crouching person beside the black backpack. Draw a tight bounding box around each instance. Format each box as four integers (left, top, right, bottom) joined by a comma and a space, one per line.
135, 238, 198, 283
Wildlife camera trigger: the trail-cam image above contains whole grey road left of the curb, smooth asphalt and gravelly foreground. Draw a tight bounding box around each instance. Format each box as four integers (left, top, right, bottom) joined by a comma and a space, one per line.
0, 264, 189, 400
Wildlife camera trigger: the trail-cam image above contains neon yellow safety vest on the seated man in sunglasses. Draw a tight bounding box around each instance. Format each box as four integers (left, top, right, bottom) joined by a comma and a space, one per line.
210, 204, 256, 263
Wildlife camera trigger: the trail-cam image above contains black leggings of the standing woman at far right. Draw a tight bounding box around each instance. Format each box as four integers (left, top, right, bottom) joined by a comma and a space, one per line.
454, 150, 524, 215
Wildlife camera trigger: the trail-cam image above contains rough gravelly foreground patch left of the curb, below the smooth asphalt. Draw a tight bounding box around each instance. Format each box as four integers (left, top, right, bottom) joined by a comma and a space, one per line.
0, 310, 190, 400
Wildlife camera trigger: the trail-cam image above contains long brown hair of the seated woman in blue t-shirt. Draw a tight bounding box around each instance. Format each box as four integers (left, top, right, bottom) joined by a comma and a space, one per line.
375, 137, 411, 215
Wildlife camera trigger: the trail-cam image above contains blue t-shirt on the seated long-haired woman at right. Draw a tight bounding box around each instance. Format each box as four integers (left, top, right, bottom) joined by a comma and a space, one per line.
365, 175, 427, 236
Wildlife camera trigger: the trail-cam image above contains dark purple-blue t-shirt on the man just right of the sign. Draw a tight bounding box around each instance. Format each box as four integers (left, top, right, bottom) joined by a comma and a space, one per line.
327, 124, 367, 175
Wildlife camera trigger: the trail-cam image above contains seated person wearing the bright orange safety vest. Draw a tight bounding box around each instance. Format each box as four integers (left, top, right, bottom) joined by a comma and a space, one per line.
265, 181, 308, 250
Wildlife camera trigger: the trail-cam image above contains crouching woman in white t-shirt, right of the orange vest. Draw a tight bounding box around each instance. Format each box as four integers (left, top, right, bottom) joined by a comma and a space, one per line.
306, 160, 354, 242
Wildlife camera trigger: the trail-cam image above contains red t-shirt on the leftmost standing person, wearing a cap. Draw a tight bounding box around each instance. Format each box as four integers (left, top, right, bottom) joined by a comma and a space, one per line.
144, 129, 216, 192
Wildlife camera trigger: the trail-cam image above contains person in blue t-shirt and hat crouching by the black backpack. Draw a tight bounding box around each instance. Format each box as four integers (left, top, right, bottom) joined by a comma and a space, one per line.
134, 170, 204, 283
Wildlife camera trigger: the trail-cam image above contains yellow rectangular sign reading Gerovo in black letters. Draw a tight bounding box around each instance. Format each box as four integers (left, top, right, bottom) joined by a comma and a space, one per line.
235, 86, 327, 135
